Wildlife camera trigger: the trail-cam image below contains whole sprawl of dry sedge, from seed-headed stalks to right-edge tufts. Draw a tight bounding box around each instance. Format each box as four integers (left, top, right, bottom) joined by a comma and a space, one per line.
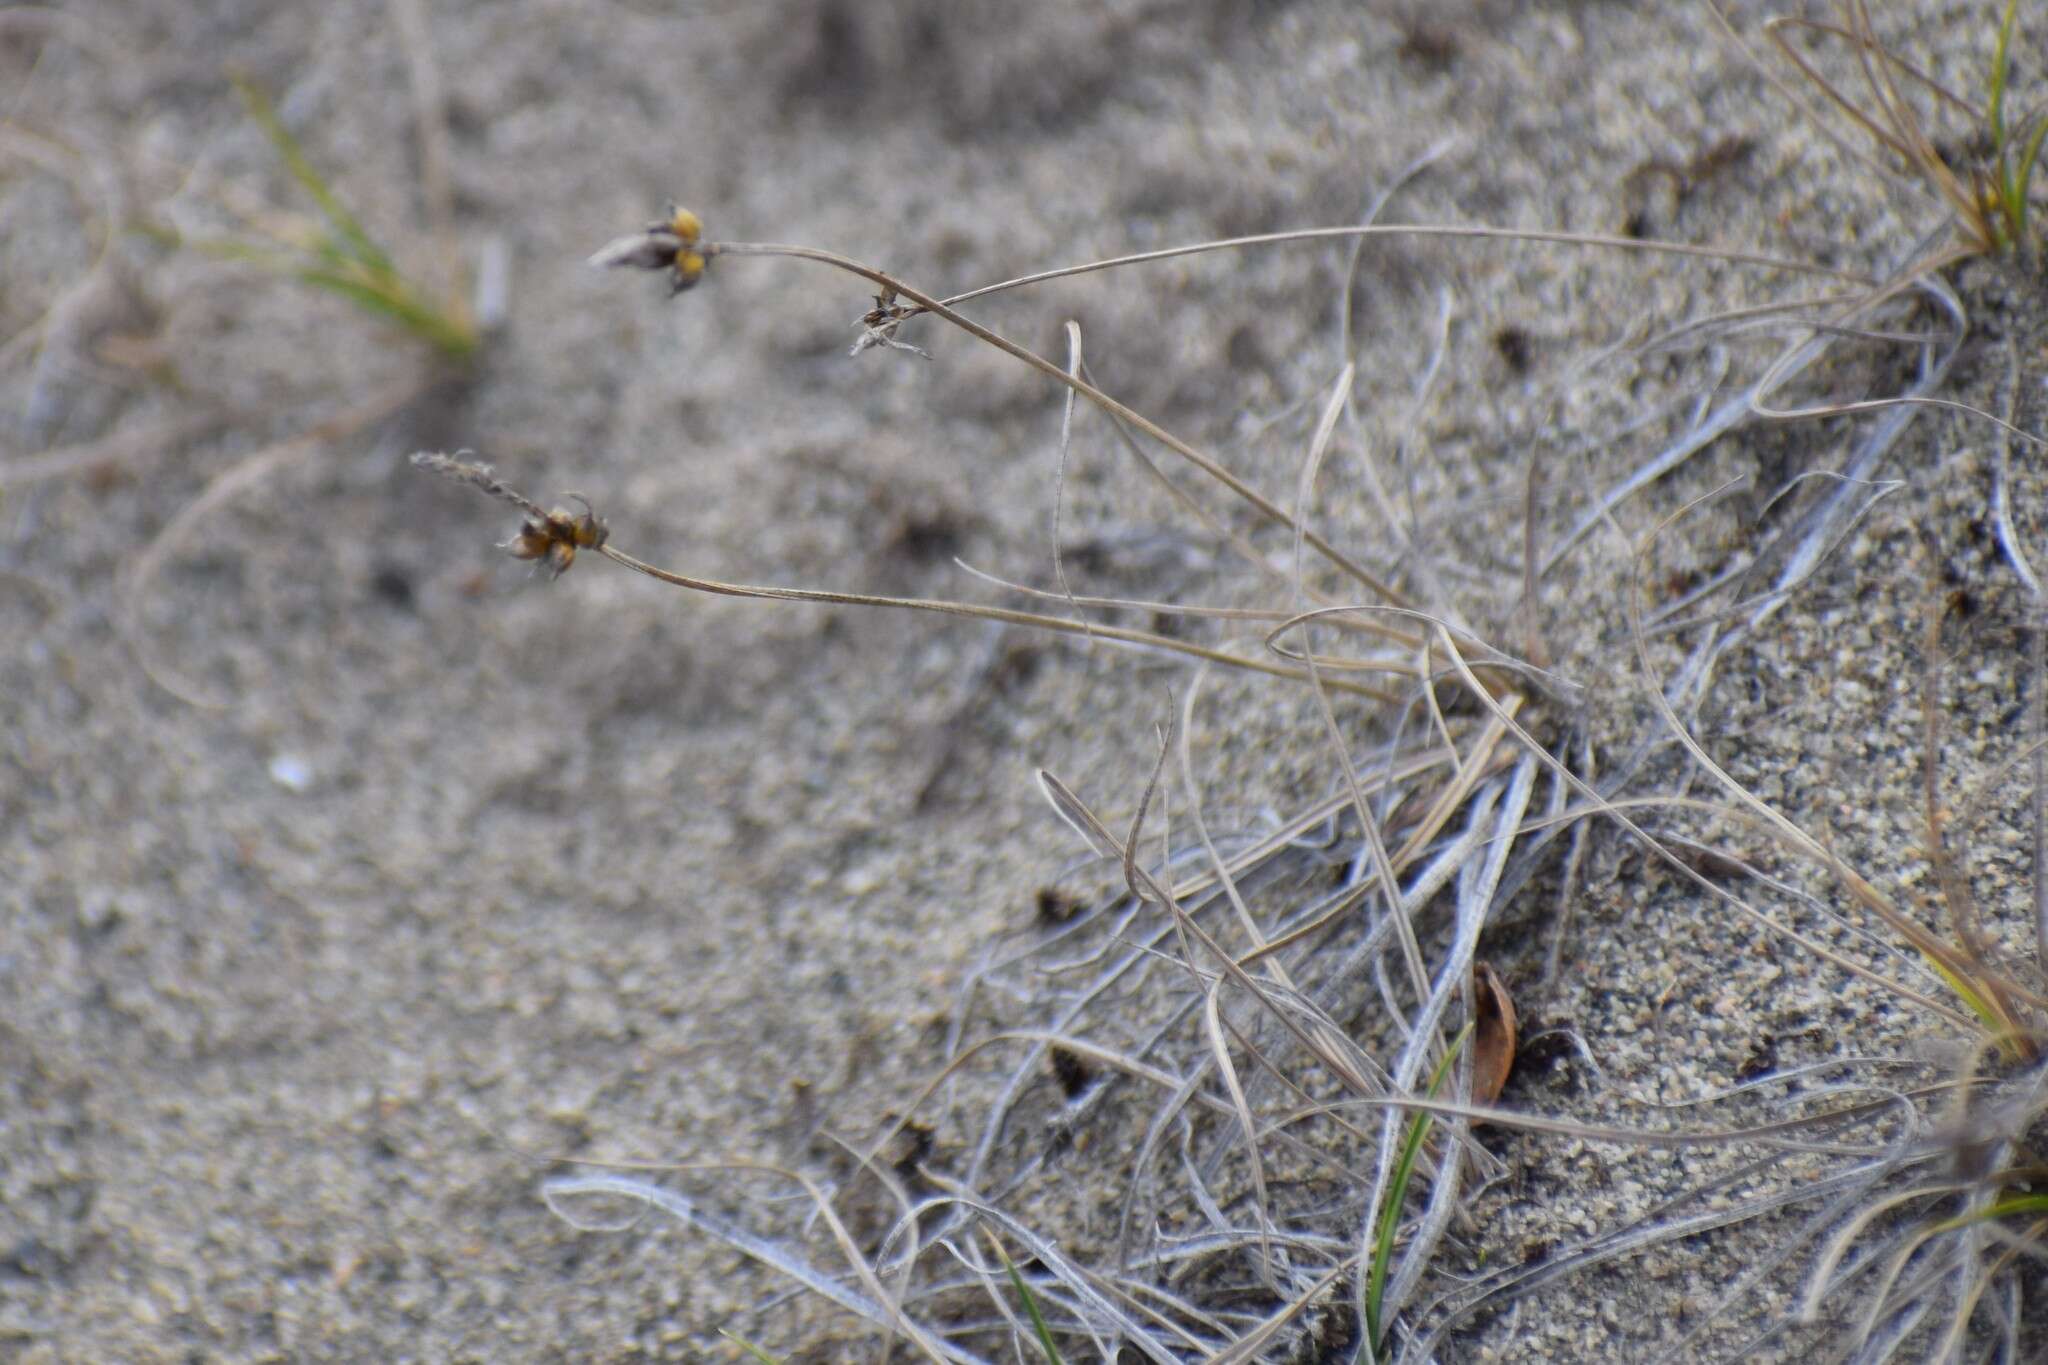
414, 10, 2048, 1361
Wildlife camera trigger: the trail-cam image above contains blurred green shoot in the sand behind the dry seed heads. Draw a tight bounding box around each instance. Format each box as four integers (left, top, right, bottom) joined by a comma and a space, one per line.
143, 78, 481, 360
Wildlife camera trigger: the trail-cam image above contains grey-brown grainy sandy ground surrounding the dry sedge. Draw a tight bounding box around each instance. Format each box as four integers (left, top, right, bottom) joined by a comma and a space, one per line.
0, 0, 2040, 1361
